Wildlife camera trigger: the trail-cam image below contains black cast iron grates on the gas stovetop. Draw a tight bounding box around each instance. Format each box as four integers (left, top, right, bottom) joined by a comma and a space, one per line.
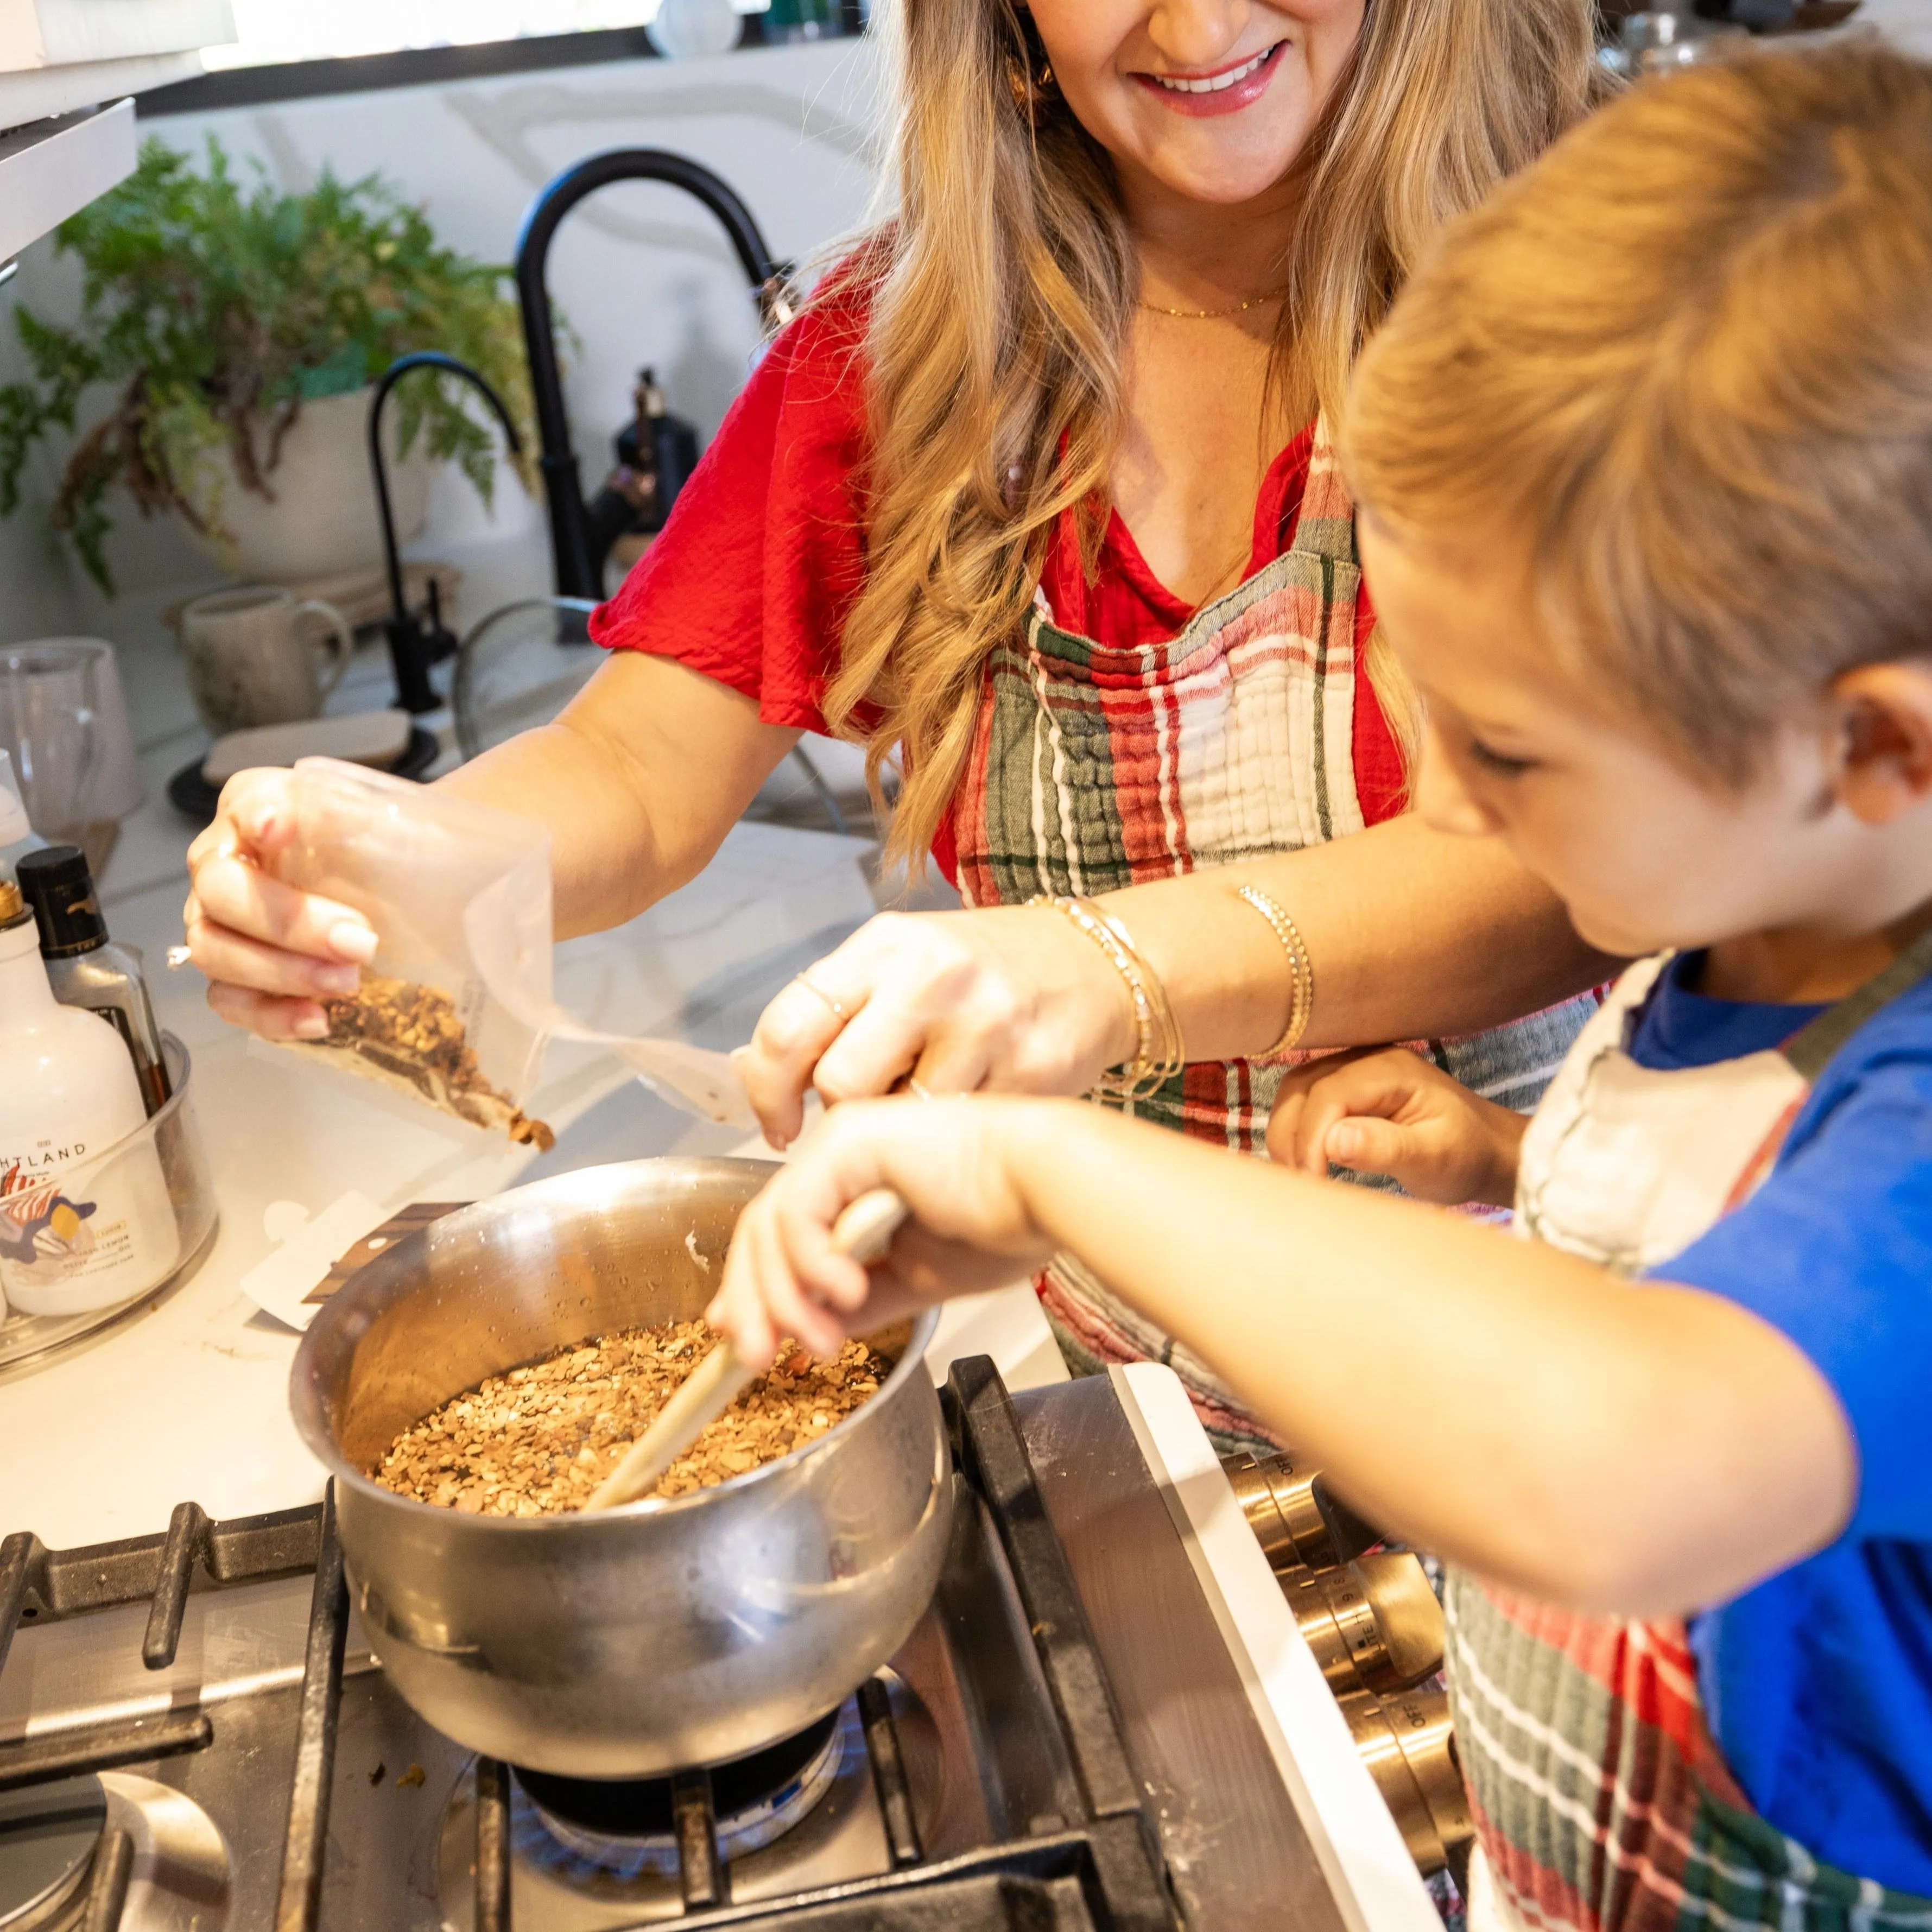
0, 1356, 1181, 1932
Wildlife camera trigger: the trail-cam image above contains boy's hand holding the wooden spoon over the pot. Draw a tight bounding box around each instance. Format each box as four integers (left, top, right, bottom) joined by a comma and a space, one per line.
705, 1098, 1080, 1368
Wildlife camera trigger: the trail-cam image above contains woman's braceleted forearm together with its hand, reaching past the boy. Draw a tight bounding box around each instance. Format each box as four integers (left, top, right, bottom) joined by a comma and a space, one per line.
740, 817, 1613, 1145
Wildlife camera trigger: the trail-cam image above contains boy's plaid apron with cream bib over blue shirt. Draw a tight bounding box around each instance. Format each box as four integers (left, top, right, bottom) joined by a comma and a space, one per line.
1445, 935, 1932, 1932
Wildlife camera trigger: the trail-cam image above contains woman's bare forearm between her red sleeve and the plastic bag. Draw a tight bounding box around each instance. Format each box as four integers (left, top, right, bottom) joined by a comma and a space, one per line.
440, 651, 800, 939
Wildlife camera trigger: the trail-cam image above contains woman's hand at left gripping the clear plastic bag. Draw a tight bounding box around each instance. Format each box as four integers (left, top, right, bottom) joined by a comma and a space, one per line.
182, 771, 377, 1040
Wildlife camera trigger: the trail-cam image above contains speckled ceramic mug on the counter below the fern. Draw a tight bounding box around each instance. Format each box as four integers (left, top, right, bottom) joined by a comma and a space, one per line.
182, 584, 356, 736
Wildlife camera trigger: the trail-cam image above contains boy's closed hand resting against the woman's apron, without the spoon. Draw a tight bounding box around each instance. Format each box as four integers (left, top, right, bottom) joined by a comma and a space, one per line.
1268, 1047, 1530, 1207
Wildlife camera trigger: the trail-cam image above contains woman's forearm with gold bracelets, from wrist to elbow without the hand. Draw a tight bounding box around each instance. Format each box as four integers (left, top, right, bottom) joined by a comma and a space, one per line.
1105, 813, 1615, 1061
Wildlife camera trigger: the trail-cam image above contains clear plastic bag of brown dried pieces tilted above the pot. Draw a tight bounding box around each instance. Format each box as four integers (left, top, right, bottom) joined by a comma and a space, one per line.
274, 757, 553, 1148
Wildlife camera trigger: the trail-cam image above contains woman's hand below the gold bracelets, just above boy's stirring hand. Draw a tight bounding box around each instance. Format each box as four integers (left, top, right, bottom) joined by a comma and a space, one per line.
736, 906, 1136, 1148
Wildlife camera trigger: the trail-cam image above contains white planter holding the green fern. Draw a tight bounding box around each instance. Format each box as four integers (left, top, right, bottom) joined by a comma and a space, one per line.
182, 388, 439, 584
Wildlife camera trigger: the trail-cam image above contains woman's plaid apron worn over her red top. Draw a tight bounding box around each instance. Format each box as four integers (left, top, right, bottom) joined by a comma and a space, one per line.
954, 423, 1596, 1447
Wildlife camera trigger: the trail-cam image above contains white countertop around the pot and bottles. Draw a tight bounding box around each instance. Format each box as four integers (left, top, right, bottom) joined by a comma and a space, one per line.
0, 618, 1065, 1549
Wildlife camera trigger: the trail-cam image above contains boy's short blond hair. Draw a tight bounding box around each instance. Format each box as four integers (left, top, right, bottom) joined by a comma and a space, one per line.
1345, 42, 1932, 784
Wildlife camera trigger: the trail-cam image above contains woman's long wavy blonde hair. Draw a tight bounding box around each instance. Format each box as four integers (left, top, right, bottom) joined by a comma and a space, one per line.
825, 0, 1601, 865
